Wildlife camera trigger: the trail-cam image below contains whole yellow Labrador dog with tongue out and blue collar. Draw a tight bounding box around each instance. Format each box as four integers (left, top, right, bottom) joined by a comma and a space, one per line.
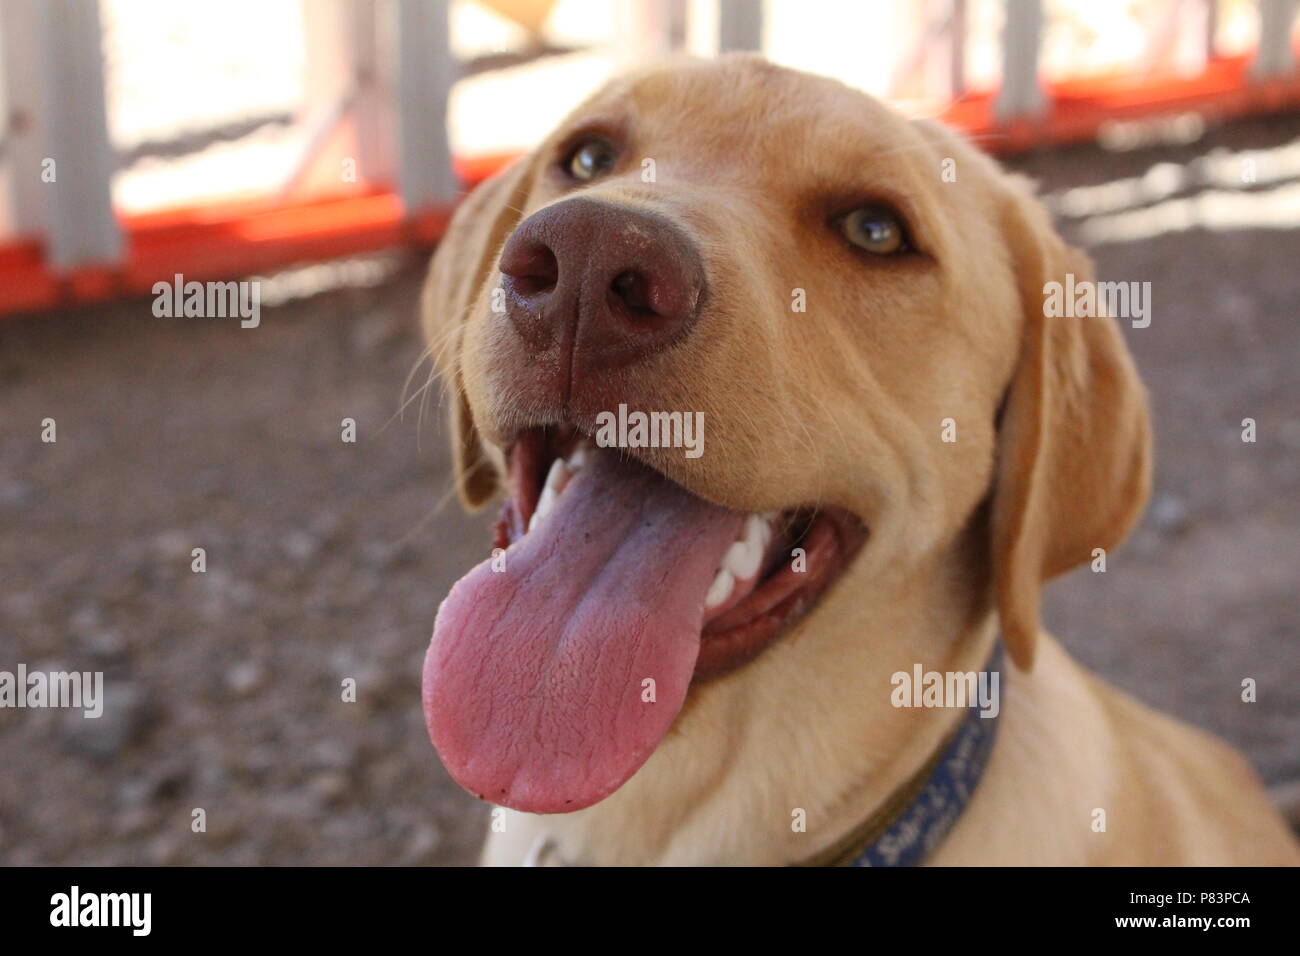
421, 55, 1300, 865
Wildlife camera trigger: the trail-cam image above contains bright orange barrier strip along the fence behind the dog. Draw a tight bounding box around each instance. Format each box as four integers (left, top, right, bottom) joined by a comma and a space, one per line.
0, 56, 1300, 313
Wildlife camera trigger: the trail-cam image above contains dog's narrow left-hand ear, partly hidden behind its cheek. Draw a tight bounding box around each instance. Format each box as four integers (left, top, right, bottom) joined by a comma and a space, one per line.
420, 153, 537, 509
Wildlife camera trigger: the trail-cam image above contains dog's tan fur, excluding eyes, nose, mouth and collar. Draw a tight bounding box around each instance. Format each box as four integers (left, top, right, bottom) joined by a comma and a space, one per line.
424, 56, 1300, 864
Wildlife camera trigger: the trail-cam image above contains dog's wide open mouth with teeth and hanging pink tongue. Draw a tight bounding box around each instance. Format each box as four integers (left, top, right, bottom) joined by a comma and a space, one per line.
424, 428, 866, 813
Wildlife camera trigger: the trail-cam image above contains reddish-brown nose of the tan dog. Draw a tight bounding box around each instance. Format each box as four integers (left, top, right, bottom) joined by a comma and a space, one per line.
499, 196, 705, 377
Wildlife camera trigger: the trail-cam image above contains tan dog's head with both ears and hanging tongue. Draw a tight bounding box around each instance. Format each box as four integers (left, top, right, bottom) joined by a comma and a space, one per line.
424, 56, 1149, 812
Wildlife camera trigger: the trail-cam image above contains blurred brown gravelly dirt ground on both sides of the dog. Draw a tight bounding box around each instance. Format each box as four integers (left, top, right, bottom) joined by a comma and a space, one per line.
0, 110, 1300, 864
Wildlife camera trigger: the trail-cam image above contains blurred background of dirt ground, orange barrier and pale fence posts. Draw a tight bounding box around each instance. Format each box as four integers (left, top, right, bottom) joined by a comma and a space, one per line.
0, 0, 1300, 864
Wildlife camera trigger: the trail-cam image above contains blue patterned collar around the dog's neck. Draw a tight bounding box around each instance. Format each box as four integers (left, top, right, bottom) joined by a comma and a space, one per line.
803, 641, 1006, 866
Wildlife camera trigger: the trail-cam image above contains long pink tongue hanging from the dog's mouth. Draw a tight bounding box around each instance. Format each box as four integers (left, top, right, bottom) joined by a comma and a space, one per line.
424, 450, 745, 813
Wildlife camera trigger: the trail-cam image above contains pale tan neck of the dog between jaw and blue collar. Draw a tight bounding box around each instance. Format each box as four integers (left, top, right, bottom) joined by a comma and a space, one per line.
522, 528, 996, 865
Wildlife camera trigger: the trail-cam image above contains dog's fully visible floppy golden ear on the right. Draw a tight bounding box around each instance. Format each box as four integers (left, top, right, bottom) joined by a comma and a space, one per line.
991, 181, 1151, 670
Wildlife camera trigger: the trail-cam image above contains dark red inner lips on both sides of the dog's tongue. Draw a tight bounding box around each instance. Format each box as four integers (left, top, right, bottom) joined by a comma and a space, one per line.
494, 427, 867, 679
